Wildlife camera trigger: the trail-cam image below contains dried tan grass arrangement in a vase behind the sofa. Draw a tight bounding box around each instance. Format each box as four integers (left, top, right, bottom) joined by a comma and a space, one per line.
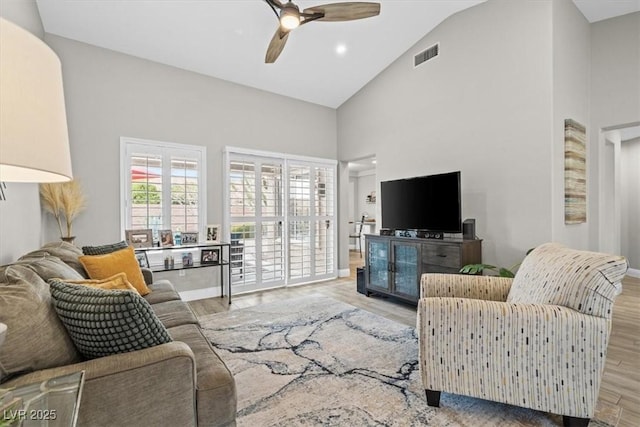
40, 179, 86, 243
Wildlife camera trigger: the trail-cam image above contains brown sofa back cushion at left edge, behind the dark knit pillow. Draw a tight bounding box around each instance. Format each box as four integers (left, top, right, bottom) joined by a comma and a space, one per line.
0, 264, 82, 382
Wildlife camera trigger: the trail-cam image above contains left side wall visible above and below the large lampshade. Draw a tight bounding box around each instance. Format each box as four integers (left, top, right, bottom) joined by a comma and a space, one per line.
0, 0, 44, 264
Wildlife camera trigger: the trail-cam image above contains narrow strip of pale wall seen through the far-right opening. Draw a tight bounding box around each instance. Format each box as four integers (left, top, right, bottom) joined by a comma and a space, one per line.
620, 139, 640, 270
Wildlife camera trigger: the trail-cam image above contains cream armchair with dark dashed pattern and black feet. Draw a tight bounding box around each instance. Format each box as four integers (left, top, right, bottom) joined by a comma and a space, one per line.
418, 243, 627, 426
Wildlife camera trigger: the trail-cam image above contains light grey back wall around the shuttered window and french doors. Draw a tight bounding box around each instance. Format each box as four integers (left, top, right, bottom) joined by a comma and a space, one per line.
46, 34, 337, 251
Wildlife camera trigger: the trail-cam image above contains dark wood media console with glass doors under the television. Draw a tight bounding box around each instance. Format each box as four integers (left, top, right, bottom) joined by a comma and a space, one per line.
365, 235, 482, 304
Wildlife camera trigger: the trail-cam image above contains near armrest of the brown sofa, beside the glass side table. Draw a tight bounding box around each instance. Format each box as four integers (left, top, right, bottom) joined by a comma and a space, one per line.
3, 341, 196, 426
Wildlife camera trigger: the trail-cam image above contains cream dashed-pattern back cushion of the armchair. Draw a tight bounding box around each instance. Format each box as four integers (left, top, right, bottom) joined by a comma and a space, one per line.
507, 243, 627, 318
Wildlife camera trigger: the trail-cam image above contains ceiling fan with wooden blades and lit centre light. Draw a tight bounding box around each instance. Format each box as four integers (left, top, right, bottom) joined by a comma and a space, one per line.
264, 0, 380, 64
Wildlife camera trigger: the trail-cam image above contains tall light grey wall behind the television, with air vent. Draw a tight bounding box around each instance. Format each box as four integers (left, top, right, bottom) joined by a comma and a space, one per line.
338, 0, 553, 265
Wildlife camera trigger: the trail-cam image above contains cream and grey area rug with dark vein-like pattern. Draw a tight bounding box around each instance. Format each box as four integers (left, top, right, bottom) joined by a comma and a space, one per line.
200, 296, 609, 427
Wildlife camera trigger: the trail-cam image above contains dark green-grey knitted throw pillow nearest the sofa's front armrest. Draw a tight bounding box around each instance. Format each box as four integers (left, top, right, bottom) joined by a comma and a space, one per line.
49, 279, 171, 359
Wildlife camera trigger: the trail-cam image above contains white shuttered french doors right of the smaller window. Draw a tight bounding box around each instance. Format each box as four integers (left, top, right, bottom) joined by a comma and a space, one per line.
225, 149, 337, 292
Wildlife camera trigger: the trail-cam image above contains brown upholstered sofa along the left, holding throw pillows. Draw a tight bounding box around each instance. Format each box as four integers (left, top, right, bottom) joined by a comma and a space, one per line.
0, 242, 237, 426
